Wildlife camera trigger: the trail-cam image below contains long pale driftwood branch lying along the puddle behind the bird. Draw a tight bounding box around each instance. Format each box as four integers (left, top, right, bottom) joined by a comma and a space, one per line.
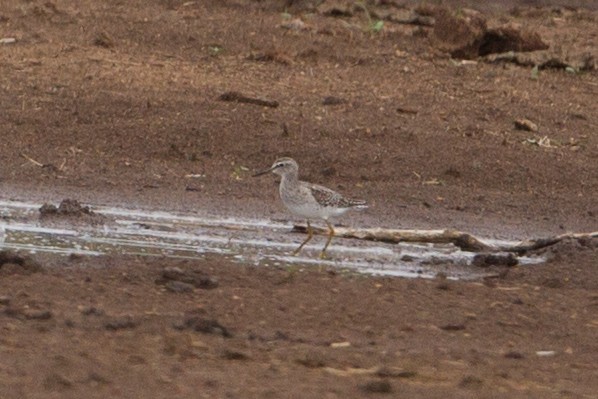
293, 225, 598, 254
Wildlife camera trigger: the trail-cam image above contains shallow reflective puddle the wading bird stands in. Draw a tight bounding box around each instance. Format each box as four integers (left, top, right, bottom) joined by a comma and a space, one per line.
0, 201, 542, 279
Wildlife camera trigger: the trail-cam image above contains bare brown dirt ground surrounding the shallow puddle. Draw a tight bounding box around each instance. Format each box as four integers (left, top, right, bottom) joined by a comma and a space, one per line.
0, 0, 598, 398
